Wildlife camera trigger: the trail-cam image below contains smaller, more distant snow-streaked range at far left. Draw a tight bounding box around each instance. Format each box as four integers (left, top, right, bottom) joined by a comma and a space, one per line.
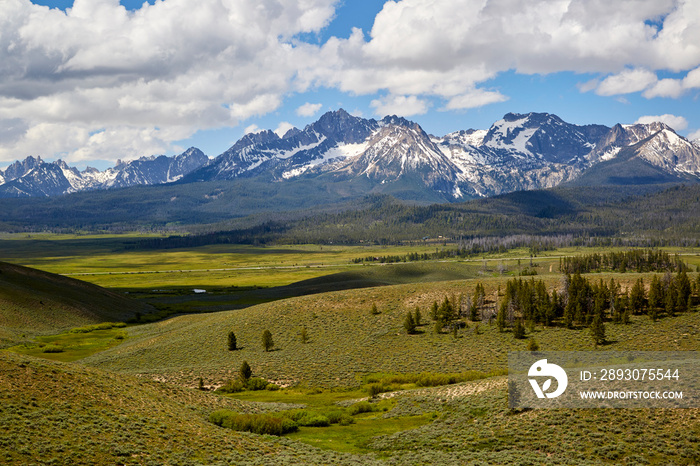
0, 148, 209, 197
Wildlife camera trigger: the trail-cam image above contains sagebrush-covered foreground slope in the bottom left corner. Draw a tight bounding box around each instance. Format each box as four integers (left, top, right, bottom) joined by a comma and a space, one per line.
0, 352, 388, 465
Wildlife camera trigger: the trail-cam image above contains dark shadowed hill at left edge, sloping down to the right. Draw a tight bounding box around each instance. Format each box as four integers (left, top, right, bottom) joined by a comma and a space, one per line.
0, 262, 152, 344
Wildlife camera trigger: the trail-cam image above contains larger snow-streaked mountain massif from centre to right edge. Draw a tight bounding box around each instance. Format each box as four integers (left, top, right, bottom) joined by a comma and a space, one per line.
185, 109, 700, 200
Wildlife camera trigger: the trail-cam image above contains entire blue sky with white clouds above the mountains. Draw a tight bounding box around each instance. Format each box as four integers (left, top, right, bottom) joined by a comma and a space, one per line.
0, 0, 700, 169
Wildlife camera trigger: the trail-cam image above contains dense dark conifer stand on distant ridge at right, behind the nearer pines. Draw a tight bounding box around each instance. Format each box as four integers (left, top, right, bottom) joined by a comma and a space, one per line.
559, 249, 688, 274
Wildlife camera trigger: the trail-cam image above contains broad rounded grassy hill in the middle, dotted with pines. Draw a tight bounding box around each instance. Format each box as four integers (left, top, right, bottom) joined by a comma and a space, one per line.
84, 273, 700, 386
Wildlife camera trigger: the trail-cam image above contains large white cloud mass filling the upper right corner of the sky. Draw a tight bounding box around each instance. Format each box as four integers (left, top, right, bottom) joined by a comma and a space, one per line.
308, 0, 700, 102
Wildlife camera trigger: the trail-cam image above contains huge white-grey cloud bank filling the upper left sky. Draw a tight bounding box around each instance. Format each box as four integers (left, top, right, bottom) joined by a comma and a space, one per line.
0, 0, 337, 161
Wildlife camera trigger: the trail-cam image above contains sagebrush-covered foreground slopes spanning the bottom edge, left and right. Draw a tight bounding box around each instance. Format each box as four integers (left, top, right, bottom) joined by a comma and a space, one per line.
0, 353, 700, 465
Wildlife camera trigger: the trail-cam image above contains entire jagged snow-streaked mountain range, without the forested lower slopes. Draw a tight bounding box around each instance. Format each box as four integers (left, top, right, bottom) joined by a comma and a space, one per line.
0, 109, 700, 201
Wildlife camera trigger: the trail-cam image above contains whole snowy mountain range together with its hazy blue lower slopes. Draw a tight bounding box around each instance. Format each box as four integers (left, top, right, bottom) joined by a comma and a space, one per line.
0, 109, 700, 228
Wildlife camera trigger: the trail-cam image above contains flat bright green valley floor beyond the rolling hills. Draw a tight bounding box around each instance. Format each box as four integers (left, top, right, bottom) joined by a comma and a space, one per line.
0, 234, 700, 290
